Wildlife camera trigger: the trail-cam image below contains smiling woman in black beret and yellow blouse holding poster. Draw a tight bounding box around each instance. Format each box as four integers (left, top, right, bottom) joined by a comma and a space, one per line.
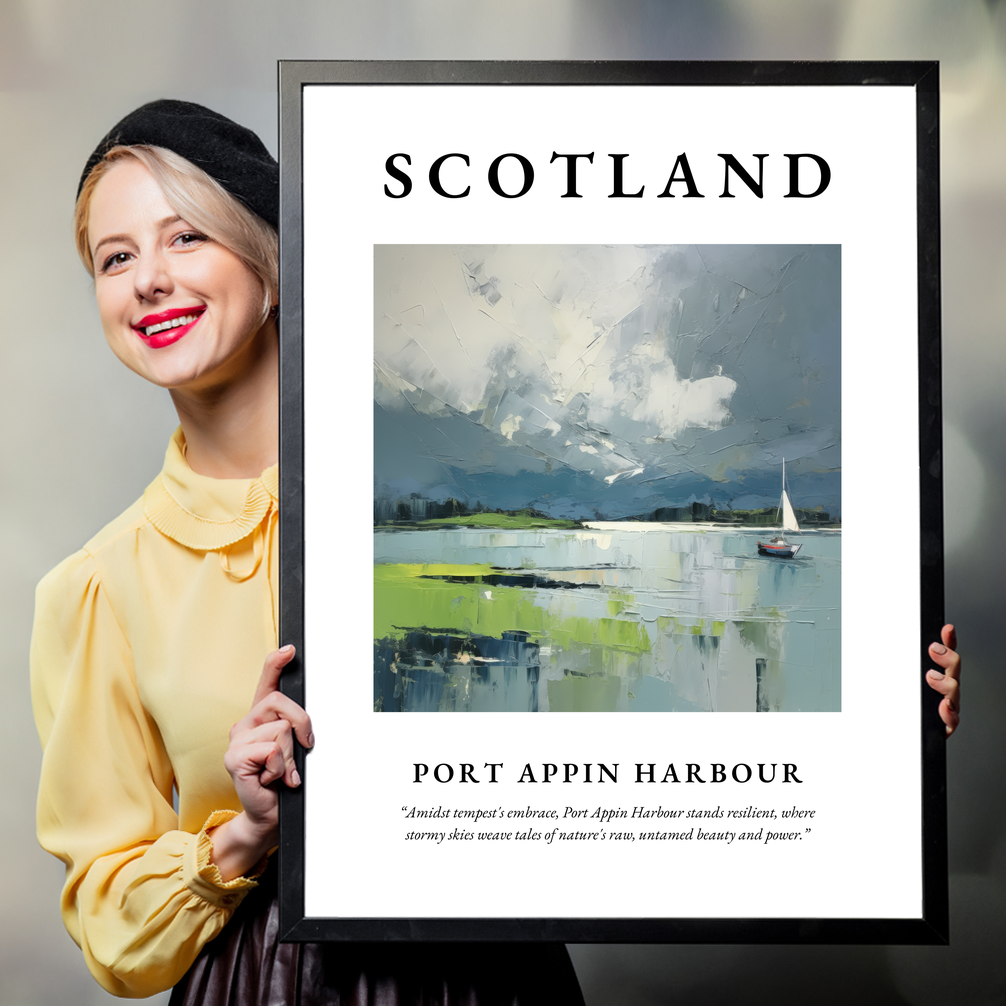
31, 102, 582, 1006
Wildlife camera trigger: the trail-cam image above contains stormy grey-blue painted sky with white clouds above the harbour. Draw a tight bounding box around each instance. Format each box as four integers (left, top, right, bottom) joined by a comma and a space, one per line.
374, 245, 841, 519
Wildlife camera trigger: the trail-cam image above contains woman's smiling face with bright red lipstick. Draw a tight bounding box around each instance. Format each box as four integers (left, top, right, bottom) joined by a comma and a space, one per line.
88, 158, 275, 392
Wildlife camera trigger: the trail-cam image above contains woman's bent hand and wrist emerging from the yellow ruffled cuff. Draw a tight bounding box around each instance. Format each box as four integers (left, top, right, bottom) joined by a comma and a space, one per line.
209, 646, 314, 880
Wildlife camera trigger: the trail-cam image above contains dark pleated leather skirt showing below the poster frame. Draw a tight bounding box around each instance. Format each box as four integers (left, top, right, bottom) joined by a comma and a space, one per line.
170, 870, 583, 1006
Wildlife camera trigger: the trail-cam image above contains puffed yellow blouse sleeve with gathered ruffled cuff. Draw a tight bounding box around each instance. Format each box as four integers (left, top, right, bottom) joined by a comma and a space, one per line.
31, 551, 263, 997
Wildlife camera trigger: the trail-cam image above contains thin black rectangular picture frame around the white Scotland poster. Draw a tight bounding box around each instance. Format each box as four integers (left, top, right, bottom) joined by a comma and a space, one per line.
279, 61, 949, 944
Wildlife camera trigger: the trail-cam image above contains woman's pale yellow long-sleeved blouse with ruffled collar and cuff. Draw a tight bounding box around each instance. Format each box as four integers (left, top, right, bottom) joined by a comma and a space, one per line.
31, 430, 278, 997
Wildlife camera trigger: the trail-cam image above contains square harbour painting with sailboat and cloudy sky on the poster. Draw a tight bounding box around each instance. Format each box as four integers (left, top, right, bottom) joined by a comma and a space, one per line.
373, 245, 841, 712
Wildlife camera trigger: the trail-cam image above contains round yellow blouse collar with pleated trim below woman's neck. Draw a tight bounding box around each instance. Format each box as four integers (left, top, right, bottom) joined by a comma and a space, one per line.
143, 427, 280, 551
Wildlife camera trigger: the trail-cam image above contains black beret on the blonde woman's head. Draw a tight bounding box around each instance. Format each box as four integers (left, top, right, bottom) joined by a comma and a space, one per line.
76, 99, 280, 227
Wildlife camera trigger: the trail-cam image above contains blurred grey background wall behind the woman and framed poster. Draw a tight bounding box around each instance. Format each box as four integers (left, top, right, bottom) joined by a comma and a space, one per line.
0, 0, 1006, 1006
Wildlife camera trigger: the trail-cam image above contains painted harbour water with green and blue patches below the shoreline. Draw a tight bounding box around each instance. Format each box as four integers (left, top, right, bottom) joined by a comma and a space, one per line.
374, 524, 841, 712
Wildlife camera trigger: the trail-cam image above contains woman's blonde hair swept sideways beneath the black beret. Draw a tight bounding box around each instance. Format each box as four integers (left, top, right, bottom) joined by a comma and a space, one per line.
73, 145, 280, 323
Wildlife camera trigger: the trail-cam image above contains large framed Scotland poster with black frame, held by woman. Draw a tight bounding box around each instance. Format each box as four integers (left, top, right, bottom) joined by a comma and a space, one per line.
280, 62, 948, 943
